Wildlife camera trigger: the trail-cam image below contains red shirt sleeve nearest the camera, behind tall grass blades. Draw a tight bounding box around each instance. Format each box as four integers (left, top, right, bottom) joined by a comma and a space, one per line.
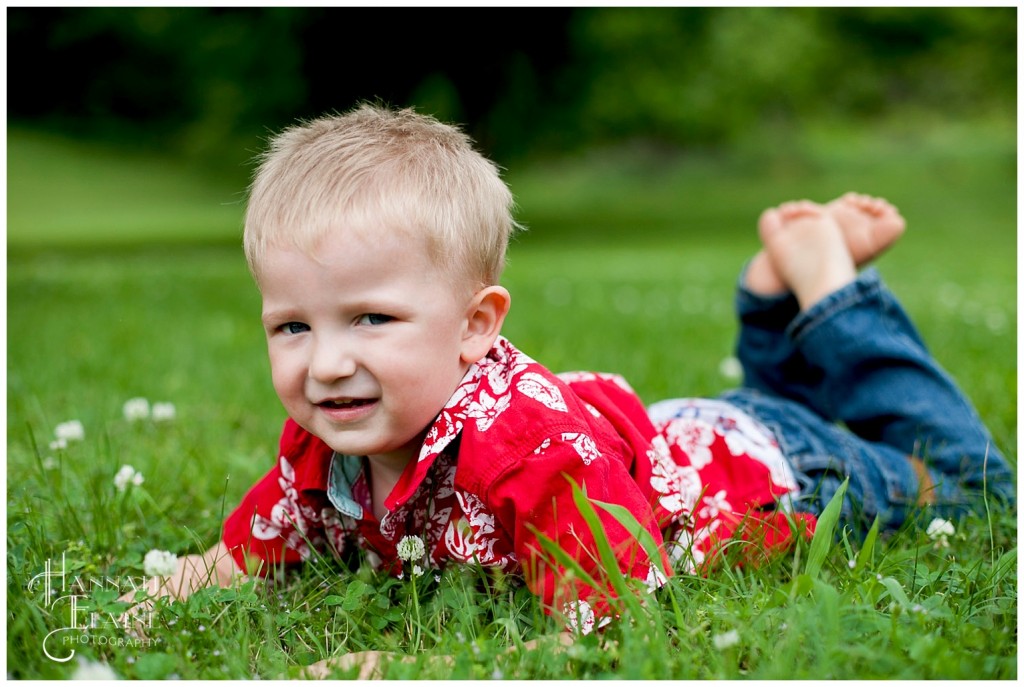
488, 433, 670, 632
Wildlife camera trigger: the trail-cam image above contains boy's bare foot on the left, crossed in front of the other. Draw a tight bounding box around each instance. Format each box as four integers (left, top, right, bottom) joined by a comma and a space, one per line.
748, 201, 857, 310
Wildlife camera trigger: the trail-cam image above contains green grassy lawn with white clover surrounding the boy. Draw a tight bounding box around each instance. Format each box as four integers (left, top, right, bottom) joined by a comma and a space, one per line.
7, 119, 1017, 679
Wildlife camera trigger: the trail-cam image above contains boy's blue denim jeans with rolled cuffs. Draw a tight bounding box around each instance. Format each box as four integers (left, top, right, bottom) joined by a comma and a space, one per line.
722, 269, 1016, 527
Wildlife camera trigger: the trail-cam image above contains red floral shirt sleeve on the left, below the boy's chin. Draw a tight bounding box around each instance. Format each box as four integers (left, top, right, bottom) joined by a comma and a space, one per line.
223, 421, 324, 575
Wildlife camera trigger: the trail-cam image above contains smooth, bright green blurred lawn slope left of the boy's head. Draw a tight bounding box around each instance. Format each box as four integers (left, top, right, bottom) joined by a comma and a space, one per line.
7, 129, 245, 247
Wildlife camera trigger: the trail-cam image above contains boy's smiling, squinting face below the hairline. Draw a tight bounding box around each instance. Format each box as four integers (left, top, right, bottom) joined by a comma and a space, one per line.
258, 231, 473, 465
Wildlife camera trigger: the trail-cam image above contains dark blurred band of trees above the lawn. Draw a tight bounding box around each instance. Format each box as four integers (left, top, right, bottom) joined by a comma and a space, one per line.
7, 7, 1017, 175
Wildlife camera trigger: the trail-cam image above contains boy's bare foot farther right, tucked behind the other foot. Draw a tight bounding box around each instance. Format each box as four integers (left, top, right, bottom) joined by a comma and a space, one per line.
825, 194, 906, 267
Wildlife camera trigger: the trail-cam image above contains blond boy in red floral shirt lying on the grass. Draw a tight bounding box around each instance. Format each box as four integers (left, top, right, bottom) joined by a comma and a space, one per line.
134, 105, 1014, 651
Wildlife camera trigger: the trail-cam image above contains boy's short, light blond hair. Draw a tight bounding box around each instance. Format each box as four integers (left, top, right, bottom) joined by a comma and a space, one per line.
244, 104, 518, 286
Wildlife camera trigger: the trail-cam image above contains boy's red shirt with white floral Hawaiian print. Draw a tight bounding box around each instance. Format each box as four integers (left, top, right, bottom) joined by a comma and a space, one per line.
223, 338, 813, 630
